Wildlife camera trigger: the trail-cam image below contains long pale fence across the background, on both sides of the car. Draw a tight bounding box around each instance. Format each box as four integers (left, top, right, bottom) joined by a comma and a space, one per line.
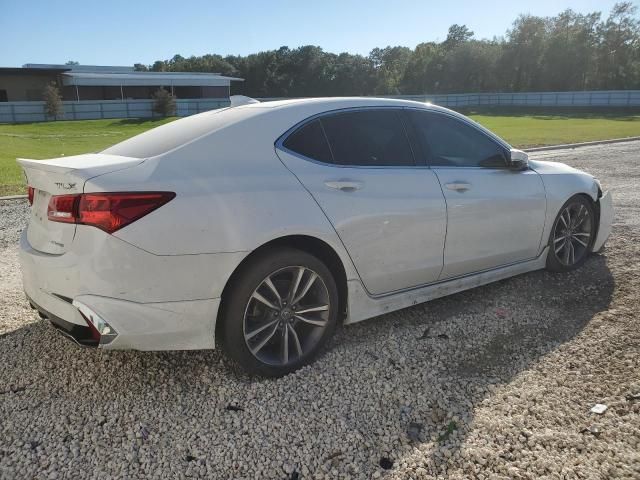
0, 90, 640, 123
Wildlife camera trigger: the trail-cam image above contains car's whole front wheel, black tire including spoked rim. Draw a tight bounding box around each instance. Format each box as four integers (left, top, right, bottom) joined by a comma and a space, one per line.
547, 195, 596, 272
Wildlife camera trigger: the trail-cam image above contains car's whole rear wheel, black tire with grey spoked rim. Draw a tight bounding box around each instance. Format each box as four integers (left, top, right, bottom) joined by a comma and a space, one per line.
218, 248, 339, 377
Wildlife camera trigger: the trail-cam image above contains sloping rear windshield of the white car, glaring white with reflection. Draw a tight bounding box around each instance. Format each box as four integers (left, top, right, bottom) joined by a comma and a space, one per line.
102, 107, 252, 158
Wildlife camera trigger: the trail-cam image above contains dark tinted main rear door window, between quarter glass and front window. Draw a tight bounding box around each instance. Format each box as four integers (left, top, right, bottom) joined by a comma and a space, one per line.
321, 110, 414, 166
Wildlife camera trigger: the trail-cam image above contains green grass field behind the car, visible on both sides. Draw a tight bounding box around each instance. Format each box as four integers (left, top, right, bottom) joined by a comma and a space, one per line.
0, 111, 640, 196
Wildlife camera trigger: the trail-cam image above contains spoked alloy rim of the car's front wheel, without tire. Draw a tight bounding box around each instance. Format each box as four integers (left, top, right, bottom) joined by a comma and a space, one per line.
553, 202, 593, 266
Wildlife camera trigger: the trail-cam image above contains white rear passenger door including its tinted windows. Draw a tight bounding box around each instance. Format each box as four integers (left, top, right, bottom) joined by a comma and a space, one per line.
276, 108, 446, 295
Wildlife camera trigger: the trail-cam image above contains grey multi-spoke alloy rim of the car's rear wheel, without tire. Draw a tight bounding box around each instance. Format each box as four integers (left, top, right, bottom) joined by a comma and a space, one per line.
242, 266, 331, 366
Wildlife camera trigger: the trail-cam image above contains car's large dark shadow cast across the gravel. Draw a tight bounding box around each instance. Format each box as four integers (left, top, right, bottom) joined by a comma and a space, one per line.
0, 255, 614, 478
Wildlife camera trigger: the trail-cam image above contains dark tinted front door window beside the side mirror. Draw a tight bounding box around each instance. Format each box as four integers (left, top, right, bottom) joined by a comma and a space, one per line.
408, 110, 507, 168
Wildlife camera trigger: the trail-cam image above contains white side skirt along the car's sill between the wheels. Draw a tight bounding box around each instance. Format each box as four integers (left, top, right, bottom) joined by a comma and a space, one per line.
345, 247, 548, 324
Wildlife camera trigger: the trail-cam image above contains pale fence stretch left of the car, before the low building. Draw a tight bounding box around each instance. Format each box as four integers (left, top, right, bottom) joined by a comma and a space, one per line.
0, 99, 229, 123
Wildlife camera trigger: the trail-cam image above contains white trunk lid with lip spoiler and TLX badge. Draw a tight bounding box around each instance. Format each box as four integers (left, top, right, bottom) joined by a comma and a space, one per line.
18, 153, 143, 255
